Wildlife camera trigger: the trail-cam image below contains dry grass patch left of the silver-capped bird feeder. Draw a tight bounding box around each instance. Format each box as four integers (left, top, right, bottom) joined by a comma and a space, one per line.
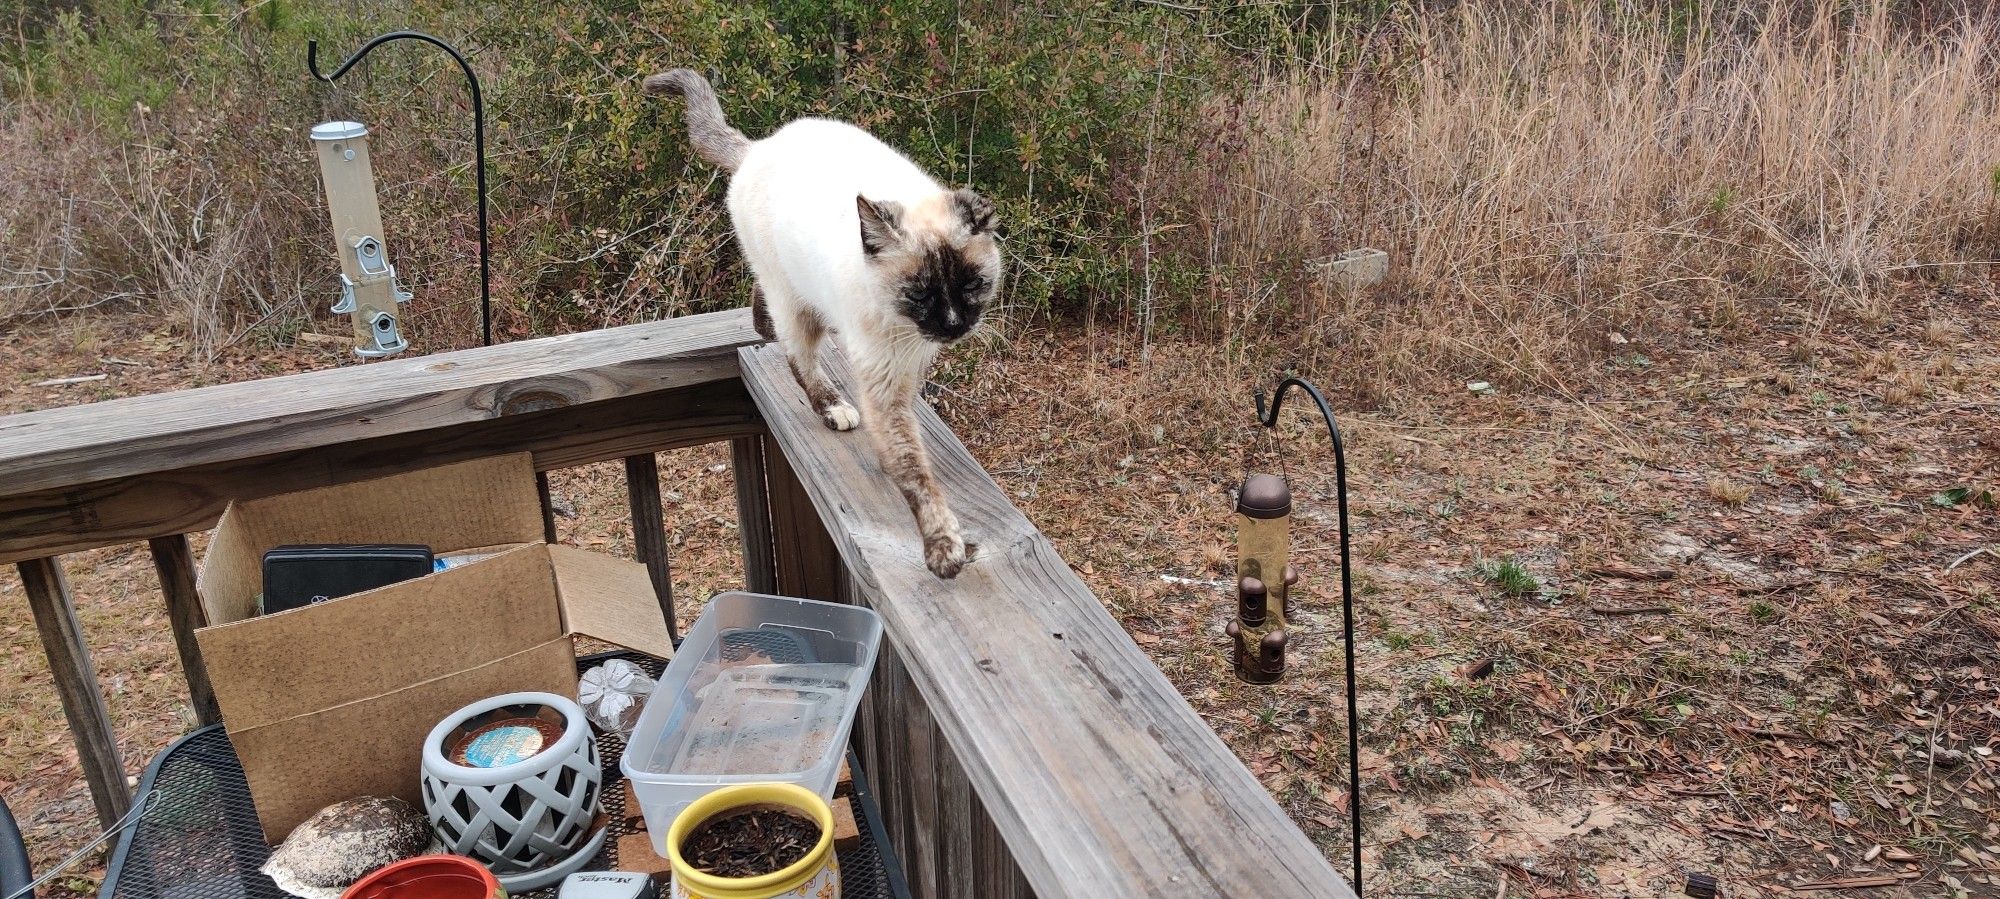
0, 104, 356, 357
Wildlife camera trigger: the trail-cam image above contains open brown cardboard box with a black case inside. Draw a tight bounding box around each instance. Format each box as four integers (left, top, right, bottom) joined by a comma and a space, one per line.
196, 453, 674, 843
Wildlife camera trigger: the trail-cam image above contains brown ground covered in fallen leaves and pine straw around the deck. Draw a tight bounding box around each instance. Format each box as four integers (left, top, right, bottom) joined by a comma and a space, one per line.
0, 286, 2000, 899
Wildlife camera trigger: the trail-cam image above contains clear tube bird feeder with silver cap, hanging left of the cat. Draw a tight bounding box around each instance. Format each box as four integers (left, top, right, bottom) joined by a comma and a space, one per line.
312, 122, 410, 360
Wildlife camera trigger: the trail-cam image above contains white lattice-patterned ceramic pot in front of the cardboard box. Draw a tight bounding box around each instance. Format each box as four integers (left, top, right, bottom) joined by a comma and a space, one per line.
424, 693, 604, 895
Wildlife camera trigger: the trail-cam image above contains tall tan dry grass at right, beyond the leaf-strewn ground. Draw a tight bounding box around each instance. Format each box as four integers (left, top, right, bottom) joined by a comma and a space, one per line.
1176, 2, 2000, 388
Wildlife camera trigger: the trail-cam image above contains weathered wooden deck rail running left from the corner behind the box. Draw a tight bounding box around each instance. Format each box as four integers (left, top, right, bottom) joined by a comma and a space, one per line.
0, 310, 760, 561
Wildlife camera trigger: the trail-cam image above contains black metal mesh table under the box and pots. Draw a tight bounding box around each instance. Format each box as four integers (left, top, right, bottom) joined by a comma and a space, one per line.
98, 653, 910, 899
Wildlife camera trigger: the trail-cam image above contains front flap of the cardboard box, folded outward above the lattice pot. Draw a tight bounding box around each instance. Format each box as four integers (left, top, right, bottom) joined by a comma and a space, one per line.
196, 543, 564, 733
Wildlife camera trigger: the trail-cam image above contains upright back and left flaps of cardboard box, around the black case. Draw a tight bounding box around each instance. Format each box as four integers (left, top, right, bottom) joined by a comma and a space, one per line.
196, 453, 542, 623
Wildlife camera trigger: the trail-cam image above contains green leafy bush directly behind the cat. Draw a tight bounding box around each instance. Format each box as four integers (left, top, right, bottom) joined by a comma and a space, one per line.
532, 0, 1222, 325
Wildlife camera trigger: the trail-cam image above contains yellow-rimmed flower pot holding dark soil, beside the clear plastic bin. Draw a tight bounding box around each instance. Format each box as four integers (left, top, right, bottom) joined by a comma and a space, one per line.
666, 783, 840, 899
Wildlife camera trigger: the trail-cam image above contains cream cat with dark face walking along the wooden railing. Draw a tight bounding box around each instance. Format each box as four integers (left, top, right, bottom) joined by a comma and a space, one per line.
646, 68, 1002, 577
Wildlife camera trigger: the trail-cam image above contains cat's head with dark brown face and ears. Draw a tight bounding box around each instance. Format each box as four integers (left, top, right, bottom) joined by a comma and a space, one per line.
854, 188, 1002, 344
